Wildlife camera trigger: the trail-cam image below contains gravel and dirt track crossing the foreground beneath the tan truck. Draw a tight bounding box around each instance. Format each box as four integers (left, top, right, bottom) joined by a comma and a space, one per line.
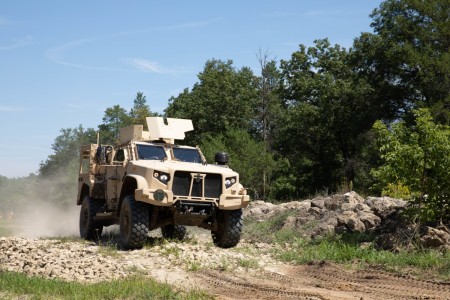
0, 229, 450, 300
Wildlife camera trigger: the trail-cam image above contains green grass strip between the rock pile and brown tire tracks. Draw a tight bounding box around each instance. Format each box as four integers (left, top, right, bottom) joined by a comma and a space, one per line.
244, 212, 450, 280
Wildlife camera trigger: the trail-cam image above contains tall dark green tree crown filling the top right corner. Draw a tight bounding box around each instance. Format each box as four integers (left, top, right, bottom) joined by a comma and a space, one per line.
371, 0, 450, 124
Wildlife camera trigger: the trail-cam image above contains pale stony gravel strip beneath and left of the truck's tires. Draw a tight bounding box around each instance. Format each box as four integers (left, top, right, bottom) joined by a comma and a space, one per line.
0, 228, 275, 284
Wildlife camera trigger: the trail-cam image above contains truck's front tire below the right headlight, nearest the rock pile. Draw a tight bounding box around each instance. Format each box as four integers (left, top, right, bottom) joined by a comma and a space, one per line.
211, 209, 243, 248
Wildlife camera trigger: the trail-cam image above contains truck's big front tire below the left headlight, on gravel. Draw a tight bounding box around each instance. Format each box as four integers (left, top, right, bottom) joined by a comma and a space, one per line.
120, 196, 149, 249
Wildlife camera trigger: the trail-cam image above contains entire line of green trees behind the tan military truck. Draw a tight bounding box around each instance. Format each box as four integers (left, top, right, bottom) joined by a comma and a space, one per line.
0, 0, 450, 223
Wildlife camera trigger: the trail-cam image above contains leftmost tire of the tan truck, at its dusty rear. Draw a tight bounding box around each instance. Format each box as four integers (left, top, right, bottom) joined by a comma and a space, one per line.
79, 195, 103, 241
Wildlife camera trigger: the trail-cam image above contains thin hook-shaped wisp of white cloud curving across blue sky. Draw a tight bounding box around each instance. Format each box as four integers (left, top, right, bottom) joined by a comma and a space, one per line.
46, 19, 216, 71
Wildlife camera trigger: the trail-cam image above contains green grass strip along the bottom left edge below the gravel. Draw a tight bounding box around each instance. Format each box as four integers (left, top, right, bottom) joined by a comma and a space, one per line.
0, 272, 212, 300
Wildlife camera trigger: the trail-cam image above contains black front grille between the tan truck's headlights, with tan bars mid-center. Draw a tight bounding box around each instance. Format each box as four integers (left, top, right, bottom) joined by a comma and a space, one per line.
172, 171, 222, 198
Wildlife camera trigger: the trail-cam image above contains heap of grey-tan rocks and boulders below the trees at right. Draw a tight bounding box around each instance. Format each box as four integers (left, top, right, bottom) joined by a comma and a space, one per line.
245, 192, 450, 250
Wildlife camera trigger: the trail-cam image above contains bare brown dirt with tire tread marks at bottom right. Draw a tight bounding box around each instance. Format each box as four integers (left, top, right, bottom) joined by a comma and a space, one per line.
196, 263, 450, 300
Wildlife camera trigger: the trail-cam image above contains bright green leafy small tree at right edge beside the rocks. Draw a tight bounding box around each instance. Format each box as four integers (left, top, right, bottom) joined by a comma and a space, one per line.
372, 109, 450, 222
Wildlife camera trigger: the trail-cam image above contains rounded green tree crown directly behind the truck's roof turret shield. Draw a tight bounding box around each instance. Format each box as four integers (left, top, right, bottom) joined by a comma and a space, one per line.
165, 59, 257, 142
